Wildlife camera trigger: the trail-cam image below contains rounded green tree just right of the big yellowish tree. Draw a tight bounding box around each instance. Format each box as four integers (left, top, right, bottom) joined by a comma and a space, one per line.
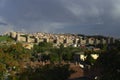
32, 42, 54, 61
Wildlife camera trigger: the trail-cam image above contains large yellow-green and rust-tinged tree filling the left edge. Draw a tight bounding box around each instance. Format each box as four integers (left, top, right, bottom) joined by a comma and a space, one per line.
0, 43, 31, 80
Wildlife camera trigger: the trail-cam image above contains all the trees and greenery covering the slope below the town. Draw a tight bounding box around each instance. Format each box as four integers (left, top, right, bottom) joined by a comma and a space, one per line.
0, 36, 120, 80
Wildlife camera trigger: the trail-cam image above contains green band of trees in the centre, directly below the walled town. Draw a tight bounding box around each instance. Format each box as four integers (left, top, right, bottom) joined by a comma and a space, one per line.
32, 42, 81, 63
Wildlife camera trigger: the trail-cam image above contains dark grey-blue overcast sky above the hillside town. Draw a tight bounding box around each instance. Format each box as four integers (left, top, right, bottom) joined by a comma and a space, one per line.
0, 0, 120, 37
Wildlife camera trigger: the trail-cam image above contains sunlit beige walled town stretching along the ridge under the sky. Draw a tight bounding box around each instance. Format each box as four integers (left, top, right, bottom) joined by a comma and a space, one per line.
9, 32, 115, 47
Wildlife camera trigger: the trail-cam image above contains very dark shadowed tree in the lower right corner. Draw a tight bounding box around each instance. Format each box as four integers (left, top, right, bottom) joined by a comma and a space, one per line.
92, 49, 120, 80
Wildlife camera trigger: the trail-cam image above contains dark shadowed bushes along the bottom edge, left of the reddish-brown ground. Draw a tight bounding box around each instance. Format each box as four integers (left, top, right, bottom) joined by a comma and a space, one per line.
20, 65, 73, 80
